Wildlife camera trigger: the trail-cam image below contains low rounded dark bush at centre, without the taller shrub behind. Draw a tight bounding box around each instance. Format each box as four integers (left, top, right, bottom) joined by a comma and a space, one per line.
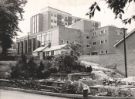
53, 54, 83, 73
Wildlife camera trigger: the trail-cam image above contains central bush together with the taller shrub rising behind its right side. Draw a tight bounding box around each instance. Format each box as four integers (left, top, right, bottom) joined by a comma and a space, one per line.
52, 43, 84, 73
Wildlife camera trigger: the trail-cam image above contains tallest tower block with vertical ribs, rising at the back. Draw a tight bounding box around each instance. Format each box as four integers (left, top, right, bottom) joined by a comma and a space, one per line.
30, 7, 81, 33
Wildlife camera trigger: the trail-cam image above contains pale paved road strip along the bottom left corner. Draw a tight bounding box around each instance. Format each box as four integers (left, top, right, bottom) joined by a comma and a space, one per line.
0, 89, 67, 99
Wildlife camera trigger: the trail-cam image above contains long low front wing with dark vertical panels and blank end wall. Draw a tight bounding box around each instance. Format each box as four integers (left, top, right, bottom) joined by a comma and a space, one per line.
17, 26, 81, 54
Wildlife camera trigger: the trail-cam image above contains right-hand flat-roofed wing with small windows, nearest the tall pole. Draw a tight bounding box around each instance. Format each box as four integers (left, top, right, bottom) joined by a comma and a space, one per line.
91, 26, 123, 55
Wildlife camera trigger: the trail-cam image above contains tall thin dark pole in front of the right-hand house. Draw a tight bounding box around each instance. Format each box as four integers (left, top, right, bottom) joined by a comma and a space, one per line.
122, 28, 128, 77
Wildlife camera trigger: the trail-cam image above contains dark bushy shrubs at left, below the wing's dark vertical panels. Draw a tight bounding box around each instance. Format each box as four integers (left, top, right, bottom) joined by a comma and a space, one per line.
11, 55, 37, 79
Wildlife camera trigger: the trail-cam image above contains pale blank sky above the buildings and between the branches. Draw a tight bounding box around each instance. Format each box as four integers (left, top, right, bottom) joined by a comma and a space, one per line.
18, 0, 135, 36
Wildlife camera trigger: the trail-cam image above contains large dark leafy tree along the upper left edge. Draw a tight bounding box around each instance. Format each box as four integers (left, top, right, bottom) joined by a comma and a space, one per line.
0, 0, 26, 55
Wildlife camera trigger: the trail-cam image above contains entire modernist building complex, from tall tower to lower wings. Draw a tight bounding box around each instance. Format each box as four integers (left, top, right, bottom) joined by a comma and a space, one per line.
17, 7, 122, 55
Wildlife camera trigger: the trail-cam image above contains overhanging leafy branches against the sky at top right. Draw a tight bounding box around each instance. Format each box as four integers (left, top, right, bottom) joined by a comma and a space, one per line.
86, 0, 135, 24
